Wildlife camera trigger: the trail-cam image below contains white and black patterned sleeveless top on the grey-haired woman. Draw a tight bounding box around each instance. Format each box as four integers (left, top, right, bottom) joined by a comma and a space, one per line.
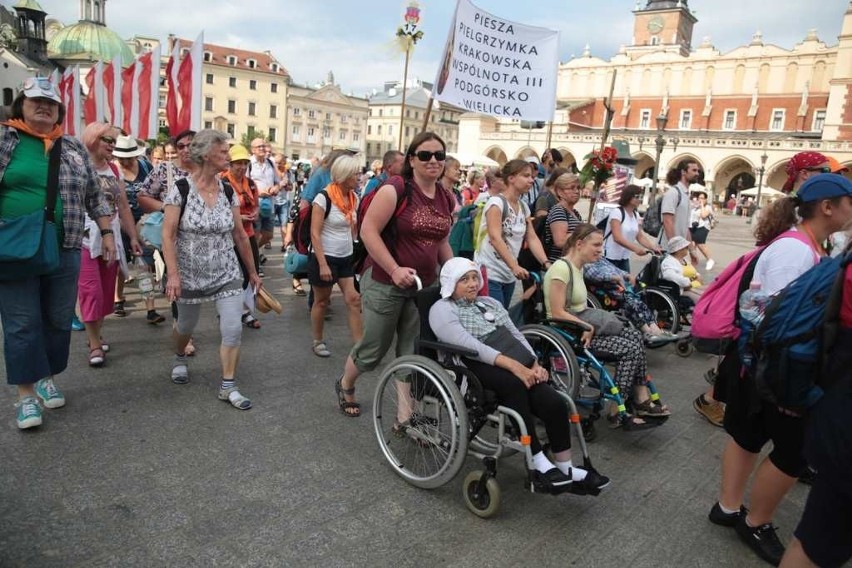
163, 178, 243, 304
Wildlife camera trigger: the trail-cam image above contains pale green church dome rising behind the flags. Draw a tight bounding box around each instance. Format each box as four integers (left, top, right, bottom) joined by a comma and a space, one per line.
47, 21, 134, 66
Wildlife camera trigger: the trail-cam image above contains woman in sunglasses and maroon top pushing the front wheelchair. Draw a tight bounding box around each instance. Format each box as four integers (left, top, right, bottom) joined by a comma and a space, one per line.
335, 132, 455, 418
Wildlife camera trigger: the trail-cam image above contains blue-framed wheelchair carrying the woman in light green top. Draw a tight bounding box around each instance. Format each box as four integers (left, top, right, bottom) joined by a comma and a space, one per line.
519, 273, 668, 442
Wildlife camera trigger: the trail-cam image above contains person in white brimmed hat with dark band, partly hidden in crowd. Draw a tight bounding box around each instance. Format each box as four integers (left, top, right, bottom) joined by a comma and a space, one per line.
112, 135, 161, 325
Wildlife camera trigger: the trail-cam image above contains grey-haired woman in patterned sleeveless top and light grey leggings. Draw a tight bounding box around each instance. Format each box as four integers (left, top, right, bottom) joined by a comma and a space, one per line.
163, 130, 263, 410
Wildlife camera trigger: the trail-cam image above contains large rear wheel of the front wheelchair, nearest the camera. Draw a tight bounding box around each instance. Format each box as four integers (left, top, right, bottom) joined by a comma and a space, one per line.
373, 355, 468, 489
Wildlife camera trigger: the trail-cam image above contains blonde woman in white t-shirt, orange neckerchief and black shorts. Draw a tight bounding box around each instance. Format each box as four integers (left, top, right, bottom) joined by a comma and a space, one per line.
308, 155, 364, 357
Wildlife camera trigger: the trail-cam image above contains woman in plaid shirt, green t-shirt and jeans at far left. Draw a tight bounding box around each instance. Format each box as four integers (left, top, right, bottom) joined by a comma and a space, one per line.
0, 78, 116, 429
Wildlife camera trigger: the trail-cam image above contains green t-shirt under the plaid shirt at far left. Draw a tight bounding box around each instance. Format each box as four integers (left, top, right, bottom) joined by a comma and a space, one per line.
0, 132, 63, 244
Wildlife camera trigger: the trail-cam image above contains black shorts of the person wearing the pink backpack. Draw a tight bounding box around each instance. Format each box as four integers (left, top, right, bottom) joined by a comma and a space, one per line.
724, 378, 807, 477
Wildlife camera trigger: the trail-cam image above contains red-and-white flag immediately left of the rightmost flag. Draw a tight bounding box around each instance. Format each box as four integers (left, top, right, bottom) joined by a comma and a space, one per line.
121, 46, 160, 140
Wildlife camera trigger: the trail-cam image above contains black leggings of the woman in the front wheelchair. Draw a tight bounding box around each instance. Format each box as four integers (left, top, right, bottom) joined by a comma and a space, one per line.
464, 359, 571, 455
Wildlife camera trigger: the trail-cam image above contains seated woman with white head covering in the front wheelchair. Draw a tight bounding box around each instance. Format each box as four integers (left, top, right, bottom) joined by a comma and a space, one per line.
429, 258, 609, 494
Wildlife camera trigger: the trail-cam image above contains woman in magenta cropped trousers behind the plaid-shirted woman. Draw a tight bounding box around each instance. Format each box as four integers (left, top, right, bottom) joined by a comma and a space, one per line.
77, 122, 142, 367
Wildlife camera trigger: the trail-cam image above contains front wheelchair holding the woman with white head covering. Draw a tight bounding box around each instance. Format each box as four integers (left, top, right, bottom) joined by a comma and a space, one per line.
373, 283, 600, 518
